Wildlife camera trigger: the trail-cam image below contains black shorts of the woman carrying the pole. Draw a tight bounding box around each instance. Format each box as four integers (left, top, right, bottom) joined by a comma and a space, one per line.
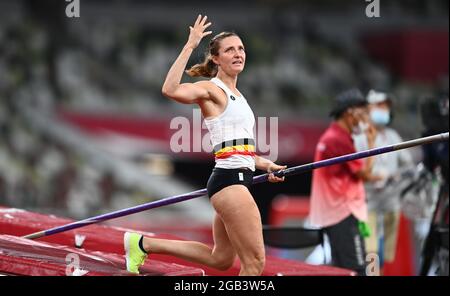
206, 168, 253, 198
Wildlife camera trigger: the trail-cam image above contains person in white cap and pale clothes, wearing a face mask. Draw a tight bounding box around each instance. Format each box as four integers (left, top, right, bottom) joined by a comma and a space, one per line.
354, 90, 414, 270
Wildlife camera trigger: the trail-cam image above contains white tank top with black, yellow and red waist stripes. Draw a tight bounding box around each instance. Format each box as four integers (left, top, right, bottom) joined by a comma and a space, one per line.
205, 77, 256, 171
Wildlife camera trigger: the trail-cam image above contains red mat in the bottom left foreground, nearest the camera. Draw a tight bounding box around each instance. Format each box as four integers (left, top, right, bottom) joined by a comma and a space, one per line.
0, 235, 204, 276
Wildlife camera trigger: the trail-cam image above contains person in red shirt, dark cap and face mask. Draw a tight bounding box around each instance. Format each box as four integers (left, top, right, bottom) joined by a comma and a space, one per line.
309, 89, 380, 275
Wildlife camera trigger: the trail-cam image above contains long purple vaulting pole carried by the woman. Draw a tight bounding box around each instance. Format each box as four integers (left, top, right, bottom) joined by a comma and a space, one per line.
24, 132, 449, 239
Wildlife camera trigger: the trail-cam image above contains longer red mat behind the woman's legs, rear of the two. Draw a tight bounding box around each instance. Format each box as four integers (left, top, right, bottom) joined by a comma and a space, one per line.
0, 207, 352, 276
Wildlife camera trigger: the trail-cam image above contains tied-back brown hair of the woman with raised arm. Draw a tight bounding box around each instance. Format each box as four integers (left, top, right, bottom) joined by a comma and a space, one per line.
185, 32, 239, 78
